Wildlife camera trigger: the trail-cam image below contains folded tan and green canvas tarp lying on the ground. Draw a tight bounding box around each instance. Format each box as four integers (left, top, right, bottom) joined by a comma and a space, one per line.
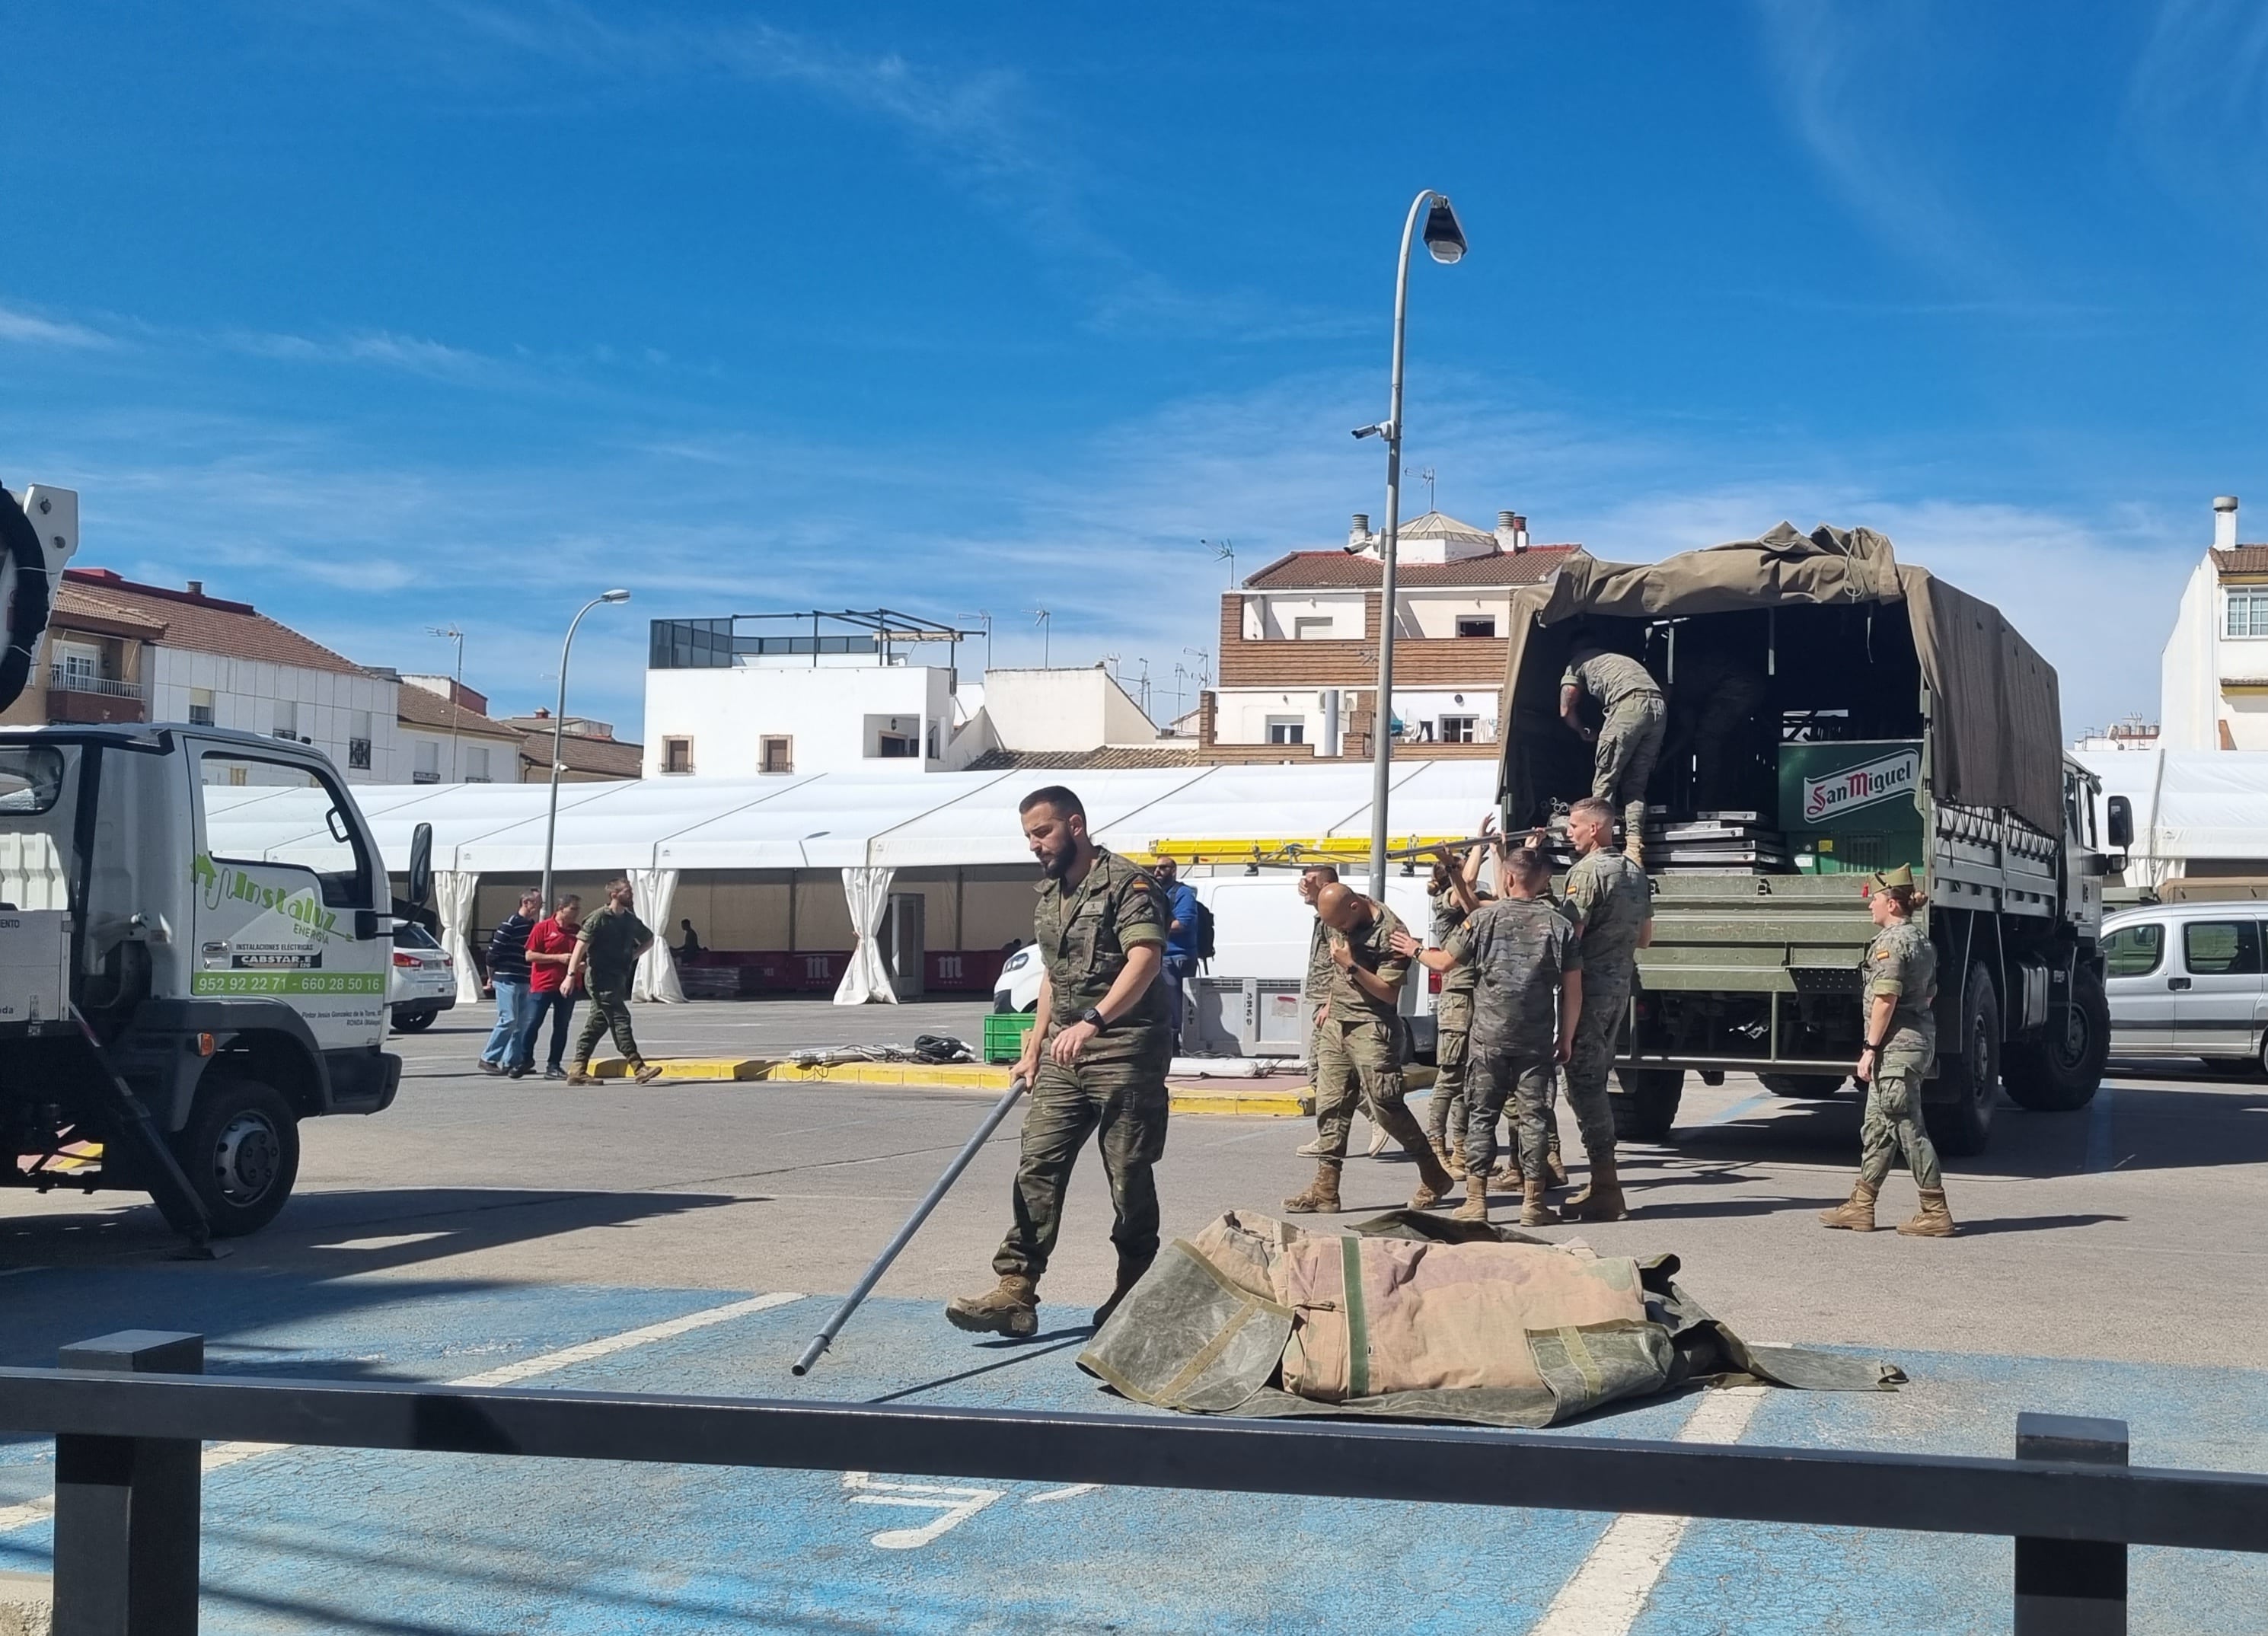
1080, 1212, 1905, 1427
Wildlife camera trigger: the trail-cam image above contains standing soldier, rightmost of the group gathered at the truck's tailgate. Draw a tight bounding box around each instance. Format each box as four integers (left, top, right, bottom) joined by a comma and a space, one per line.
1561, 796, 1654, 1221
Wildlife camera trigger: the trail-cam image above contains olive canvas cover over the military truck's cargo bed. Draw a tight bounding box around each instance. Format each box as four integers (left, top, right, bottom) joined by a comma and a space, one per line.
1504, 522, 2064, 835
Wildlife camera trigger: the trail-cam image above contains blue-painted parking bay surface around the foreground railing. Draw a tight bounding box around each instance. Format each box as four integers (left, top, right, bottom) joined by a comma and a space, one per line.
0, 1268, 2268, 1636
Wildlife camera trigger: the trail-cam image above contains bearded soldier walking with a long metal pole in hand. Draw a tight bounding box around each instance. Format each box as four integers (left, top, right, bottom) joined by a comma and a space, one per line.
946, 785, 1172, 1335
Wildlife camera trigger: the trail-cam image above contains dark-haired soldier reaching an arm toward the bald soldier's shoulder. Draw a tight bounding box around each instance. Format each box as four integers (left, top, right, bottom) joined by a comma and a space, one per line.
1395, 849, 1583, 1227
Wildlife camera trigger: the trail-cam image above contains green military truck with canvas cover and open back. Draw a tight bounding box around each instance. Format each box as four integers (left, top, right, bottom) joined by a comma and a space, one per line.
1501, 522, 2132, 1155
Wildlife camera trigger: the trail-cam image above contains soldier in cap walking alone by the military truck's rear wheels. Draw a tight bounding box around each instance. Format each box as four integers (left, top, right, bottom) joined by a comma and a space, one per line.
1819, 865, 1955, 1239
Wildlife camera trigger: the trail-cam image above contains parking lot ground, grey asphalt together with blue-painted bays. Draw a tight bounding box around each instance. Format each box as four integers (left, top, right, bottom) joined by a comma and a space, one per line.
0, 1000, 2268, 1631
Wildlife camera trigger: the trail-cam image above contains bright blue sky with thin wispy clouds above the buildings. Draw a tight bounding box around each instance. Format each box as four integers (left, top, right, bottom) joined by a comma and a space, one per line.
0, 0, 2268, 733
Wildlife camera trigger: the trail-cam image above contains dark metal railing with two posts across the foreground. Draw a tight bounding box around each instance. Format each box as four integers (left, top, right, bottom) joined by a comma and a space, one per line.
0, 1330, 2268, 1636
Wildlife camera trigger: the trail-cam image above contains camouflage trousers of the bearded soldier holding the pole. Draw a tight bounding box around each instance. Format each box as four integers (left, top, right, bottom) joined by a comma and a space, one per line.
994, 1055, 1168, 1280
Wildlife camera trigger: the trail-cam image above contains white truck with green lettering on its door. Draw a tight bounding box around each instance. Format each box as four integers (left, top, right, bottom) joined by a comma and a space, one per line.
0, 488, 431, 1243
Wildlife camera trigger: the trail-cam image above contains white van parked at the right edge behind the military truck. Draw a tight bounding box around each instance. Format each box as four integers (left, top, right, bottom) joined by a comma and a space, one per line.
2103, 903, 2268, 1073
